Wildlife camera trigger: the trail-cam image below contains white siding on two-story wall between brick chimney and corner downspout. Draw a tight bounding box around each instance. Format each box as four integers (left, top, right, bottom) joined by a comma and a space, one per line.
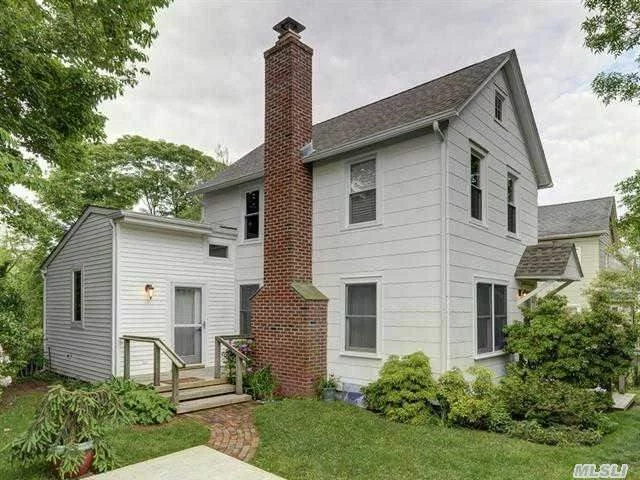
313, 134, 441, 385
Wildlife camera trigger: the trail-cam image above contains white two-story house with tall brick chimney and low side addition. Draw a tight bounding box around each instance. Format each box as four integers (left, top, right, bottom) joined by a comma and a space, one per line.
44, 19, 580, 394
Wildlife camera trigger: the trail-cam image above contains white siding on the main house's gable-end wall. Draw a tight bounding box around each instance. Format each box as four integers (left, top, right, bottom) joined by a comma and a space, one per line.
447, 68, 538, 374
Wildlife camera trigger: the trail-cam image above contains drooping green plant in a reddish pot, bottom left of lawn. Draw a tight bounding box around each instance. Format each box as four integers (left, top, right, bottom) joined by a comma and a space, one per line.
11, 385, 127, 478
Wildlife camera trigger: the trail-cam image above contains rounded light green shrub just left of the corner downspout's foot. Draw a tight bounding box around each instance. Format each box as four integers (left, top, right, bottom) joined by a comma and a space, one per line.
362, 352, 436, 423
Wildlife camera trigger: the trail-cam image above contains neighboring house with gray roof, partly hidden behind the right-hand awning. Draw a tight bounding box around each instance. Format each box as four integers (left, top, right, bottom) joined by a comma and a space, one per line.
538, 197, 617, 310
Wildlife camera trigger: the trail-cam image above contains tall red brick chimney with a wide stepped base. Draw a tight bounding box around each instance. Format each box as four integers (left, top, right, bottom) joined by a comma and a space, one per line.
251, 17, 327, 396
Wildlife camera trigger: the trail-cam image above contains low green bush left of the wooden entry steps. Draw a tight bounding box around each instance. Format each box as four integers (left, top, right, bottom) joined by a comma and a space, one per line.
103, 378, 174, 425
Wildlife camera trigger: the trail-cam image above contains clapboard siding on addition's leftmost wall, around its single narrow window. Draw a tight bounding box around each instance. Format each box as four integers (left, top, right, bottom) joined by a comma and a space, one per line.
45, 213, 113, 381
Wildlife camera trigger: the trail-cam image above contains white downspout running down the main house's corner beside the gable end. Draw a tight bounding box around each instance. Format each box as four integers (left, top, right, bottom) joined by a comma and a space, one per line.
433, 120, 450, 373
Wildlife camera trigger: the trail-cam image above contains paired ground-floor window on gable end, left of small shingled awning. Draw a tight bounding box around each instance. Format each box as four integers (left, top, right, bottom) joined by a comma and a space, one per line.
476, 283, 507, 355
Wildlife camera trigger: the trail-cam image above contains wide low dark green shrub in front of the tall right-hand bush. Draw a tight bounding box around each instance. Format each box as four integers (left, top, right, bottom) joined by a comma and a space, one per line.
500, 368, 610, 431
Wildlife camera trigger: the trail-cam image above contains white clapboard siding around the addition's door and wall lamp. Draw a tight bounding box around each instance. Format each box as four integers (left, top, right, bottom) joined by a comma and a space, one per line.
117, 224, 237, 375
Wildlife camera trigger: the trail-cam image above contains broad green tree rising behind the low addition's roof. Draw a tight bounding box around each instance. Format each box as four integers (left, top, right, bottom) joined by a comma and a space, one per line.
40, 136, 226, 223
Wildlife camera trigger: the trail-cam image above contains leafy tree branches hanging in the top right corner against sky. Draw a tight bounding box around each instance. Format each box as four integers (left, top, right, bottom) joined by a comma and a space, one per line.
582, 0, 640, 104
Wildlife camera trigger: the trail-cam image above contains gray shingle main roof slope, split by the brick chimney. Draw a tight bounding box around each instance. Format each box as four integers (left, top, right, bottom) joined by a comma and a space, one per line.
194, 50, 514, 193
